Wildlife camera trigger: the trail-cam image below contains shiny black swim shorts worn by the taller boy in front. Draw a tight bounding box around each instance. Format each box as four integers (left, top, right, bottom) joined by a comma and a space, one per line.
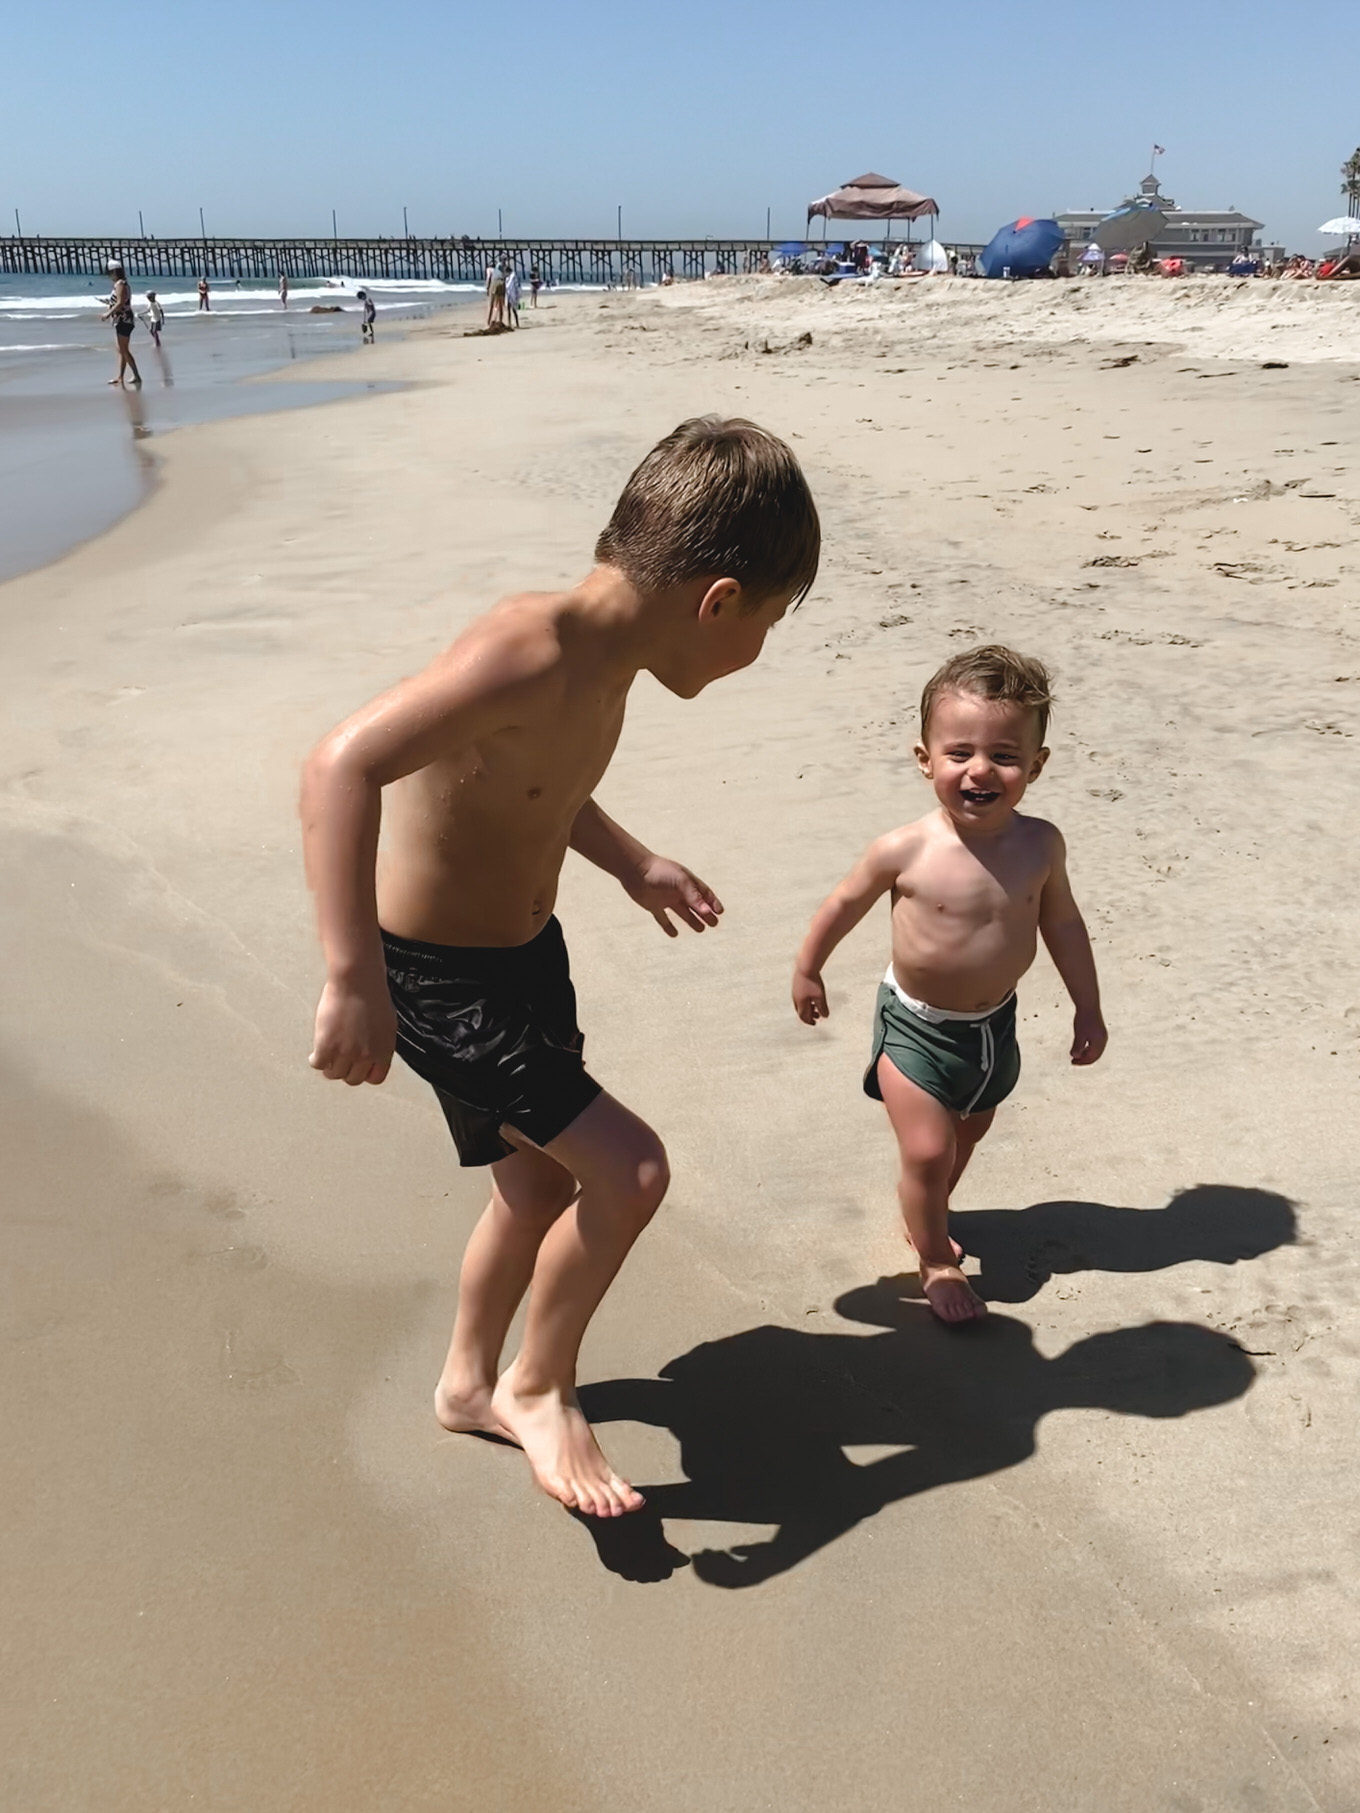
383, 917, 600, 1166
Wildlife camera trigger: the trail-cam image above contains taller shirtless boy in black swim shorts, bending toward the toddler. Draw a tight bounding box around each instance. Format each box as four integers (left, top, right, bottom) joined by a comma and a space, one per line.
303, 419, 820, 1517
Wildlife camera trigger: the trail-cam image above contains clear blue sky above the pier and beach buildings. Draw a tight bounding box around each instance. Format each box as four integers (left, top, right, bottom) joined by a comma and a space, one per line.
0, 0, 1360, 250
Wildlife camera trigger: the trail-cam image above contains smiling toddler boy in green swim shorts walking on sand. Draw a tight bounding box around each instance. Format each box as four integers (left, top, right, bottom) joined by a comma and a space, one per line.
792, 645, 1108, 1322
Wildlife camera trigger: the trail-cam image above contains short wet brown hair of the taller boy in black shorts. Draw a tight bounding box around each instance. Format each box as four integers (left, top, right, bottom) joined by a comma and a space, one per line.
595, 415, 821, 609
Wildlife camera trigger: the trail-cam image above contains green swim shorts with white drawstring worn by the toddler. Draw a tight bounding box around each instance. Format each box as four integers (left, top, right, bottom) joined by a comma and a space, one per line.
865, 970, 1019, 1119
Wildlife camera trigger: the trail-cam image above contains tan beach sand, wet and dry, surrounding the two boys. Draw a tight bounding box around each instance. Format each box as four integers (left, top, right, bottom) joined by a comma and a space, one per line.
0, 281, 1360, 1813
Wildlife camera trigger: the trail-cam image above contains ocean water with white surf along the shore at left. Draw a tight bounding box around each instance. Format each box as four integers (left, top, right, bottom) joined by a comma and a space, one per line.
0, 277, 481, 580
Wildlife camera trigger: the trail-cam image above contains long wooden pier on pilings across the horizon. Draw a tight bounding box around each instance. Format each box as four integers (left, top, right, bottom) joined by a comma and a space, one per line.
0, 236, 819, 286
